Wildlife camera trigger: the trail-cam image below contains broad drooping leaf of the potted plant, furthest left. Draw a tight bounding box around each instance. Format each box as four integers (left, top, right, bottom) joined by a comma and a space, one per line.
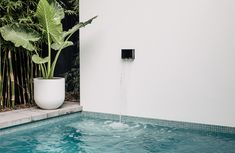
0, 25, 40, 51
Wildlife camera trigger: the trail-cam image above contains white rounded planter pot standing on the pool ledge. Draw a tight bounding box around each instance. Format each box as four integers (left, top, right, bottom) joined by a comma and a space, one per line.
33, 77, 65, 109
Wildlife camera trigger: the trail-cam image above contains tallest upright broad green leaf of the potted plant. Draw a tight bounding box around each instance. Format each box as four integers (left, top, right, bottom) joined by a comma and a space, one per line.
36, 0, 64, 43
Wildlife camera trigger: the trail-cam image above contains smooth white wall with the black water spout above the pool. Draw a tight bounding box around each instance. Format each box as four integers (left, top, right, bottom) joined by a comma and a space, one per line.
80, 0, 235, 127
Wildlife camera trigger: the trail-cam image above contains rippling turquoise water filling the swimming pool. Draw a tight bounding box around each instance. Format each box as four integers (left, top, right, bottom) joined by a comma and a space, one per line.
0, 113, 235, 153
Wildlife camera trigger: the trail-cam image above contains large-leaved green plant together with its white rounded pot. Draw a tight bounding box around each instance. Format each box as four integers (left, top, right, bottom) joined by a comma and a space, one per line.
0, 0, 96, 109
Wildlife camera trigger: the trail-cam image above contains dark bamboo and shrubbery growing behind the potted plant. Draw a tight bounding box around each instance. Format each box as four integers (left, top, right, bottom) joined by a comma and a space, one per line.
0, 0, 79, 111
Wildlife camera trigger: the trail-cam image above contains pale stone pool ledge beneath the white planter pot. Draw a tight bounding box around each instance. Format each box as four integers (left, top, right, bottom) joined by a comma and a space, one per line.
0, 102, 82, 129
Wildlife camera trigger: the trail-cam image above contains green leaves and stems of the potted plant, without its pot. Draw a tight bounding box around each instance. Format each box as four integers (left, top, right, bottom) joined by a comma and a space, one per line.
0, 0, 96, 79
